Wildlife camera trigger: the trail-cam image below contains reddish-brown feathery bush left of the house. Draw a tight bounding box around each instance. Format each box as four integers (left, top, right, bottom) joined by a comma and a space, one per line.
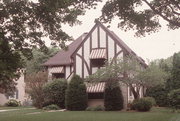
25, 71, 48, 108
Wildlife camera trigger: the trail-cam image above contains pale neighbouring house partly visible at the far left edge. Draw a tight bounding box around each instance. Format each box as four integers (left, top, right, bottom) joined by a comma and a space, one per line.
0, 73, 26, 105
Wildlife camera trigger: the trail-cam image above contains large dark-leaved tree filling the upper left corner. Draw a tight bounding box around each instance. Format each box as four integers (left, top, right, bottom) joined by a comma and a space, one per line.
0, 0, 99, 92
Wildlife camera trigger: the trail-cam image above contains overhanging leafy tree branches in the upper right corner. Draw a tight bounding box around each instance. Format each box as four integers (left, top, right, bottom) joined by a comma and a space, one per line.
100, 0, 180, 36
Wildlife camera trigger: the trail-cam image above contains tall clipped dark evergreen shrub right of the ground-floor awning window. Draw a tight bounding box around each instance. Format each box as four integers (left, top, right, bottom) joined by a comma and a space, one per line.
104, 80, 123, 111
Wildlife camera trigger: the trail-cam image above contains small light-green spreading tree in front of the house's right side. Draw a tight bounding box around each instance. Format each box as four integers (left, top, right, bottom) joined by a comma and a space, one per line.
87, 56, 168, 99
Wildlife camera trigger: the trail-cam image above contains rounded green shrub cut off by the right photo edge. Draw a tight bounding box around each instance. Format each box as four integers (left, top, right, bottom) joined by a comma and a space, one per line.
168, 89, 180, 109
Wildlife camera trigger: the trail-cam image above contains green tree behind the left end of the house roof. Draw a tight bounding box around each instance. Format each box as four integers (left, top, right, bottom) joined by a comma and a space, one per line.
25, 48, 59, 74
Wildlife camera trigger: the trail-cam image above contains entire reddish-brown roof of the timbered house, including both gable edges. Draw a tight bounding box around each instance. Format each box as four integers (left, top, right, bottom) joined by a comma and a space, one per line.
43, 20, 147, 67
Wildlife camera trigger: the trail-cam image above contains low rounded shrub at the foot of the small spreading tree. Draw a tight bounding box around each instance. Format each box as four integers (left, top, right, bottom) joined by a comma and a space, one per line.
132, 98, 152, 111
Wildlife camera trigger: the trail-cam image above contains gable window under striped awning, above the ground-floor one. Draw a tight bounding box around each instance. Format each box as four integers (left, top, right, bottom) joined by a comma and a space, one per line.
90, 48, 107, 67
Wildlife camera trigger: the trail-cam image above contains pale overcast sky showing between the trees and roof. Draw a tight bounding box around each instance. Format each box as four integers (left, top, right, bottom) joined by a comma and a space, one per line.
60, 2, 180, 61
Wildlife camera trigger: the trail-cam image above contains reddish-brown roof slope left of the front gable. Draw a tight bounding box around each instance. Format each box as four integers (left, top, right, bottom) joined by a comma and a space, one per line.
43, 33, 87, 66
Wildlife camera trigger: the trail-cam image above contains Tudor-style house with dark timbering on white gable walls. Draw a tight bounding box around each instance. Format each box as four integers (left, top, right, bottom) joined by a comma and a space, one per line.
44, 20, 147, 106
